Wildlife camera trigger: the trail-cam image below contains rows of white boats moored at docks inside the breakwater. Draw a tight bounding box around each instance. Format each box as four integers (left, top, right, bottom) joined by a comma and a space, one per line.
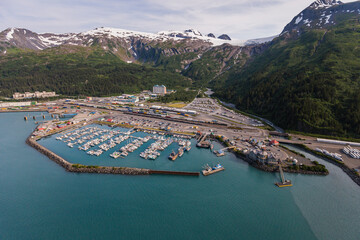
51, 125, 191, 160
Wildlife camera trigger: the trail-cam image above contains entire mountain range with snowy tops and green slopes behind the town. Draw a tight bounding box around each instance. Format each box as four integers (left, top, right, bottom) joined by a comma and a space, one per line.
0, 0, 360, 137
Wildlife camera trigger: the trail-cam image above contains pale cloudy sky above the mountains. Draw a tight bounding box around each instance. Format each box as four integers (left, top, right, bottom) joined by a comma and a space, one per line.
0, 0, 352, 39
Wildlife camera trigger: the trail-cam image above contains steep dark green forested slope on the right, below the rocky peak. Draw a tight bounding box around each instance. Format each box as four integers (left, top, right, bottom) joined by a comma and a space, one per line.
211, 14, 360, 136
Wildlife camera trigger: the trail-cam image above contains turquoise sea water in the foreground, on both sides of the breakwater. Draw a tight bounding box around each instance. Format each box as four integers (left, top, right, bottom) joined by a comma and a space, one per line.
0, 113, 360, 239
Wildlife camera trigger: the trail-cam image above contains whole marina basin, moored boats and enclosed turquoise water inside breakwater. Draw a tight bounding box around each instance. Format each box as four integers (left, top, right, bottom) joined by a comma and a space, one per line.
39, 124, 201, 172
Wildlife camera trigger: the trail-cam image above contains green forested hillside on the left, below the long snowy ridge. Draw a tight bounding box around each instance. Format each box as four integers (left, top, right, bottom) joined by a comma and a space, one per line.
0, 46, 191, 96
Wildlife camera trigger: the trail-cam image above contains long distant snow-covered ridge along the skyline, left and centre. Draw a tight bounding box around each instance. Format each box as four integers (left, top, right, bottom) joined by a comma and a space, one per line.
0, 27, 276, 53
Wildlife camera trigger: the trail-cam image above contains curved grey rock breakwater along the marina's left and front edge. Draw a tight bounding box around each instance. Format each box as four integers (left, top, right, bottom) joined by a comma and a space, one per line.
26, 136, 150, 175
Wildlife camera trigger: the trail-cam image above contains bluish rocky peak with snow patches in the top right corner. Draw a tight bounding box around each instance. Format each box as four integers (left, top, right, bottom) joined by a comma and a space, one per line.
281, 0, 360, 34
